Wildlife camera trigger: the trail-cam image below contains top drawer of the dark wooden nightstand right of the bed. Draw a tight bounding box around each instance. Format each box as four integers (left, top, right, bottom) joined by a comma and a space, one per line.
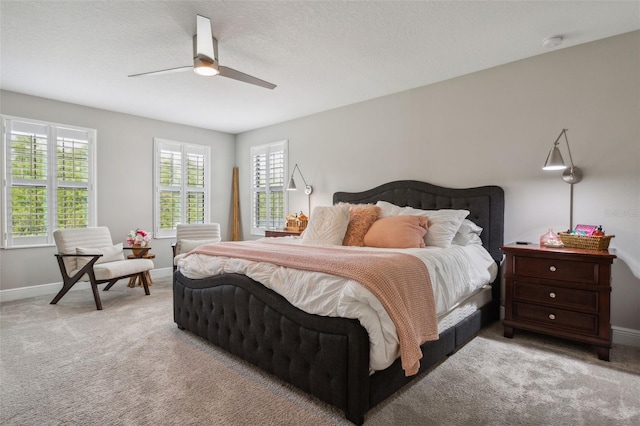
514, 256, 598, 284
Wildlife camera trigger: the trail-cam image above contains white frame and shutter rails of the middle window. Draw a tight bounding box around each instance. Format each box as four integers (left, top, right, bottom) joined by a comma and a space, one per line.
153, 138, 211, 238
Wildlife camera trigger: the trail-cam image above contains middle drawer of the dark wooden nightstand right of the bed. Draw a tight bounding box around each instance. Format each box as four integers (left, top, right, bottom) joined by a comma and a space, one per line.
513, 280, 599, 312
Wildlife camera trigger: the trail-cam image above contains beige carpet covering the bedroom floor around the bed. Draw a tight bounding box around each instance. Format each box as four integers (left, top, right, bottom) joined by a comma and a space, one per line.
0, 278, 640, 425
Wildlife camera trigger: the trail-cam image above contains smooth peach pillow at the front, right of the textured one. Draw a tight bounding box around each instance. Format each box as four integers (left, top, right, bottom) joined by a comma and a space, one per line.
364, 215, 427, 248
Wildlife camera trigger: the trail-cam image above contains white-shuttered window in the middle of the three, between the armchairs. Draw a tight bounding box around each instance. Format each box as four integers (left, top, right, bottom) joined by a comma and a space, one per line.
154, 138, 209, 238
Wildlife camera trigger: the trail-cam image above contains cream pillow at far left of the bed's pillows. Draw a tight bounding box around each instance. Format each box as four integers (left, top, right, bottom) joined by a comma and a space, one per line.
302, 204, 349, 245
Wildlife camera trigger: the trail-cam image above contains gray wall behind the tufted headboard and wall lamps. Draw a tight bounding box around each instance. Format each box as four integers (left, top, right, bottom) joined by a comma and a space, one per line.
236, 32, 640, 331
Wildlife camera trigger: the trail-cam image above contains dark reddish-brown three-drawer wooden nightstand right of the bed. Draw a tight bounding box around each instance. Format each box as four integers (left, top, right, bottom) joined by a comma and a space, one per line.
502, 244, 616, 361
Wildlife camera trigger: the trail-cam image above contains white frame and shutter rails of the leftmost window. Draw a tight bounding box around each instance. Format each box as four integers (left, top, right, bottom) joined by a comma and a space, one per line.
0, 115, 98, 249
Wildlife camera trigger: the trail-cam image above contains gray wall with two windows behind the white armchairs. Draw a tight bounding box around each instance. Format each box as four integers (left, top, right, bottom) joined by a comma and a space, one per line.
0, 91, 235, 290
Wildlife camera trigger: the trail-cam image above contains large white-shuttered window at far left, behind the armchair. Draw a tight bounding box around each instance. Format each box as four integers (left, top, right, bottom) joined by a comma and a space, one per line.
0, 116, 96, 247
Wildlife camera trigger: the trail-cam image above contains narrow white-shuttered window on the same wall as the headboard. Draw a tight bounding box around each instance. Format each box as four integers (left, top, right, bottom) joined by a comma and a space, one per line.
251, 140, 287, 235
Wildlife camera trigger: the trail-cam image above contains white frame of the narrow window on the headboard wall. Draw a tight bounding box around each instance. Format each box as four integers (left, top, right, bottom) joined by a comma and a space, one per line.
249, 139, 289, 236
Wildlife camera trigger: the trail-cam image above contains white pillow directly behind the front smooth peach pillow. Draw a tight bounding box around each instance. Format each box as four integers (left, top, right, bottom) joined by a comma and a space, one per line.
376, 201, 469, 248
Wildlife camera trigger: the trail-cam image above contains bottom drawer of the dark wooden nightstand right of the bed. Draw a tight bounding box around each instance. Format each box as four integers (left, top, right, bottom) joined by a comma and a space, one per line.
513, 303, 598, 335
